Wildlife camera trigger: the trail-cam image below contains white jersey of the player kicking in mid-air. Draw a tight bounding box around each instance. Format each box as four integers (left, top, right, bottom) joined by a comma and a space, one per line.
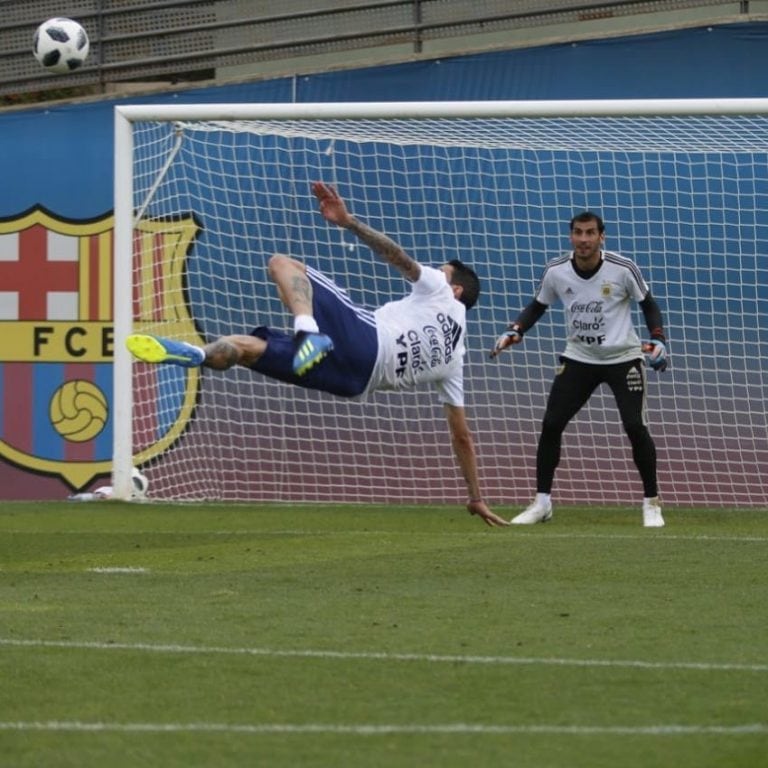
366, 266, 466, 406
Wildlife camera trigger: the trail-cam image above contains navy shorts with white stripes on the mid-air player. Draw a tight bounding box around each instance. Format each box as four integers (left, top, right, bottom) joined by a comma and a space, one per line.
251, 267, 379, 397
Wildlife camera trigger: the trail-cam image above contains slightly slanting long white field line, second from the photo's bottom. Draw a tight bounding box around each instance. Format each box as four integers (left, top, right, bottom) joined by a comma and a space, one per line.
0, 637, 768, 672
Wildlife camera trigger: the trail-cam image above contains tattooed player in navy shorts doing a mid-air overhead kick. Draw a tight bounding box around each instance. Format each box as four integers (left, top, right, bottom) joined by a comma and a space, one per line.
126, 182, 508, 526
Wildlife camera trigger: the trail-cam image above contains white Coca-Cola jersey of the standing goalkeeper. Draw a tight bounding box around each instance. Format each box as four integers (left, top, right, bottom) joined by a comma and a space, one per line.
536, 251, 648, 363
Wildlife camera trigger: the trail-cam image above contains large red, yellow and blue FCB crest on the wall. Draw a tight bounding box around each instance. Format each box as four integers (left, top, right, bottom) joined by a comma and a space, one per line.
0, 207, 197, 490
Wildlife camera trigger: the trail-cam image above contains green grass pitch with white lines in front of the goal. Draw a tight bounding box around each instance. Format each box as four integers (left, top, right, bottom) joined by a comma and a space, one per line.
0, 502, 768, 768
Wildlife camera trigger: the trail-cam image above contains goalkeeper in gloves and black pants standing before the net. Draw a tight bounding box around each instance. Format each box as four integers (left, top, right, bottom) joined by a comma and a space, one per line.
491, 211, 667, 528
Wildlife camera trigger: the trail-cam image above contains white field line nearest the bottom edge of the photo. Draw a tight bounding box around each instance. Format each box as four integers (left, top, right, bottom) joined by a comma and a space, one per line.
0, 720, 768, 736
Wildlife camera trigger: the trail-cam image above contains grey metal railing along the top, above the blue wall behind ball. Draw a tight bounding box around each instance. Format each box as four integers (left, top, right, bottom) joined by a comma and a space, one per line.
0, 0, 749, 104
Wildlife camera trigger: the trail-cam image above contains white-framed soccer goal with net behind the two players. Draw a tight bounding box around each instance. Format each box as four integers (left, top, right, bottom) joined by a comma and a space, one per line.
112, 99, 768, 507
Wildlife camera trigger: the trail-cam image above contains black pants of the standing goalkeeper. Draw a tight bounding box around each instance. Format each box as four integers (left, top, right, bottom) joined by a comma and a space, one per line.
536, 357, 659, 498
